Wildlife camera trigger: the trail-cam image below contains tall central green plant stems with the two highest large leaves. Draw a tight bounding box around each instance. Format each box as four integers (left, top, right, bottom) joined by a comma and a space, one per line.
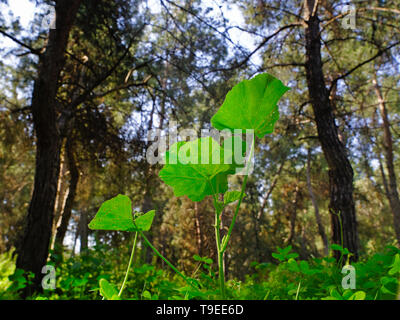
159, 74, 289, 298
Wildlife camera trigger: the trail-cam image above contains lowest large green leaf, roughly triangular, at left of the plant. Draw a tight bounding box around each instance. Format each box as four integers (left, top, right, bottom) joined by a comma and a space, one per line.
89, 194, 136, 231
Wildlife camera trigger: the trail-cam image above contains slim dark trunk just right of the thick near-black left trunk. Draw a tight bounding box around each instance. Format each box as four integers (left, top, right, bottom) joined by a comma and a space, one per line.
55, 141, 79, 248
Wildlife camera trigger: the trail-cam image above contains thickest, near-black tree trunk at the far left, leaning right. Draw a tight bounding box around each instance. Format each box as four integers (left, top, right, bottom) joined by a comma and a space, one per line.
16, 0, 81, 295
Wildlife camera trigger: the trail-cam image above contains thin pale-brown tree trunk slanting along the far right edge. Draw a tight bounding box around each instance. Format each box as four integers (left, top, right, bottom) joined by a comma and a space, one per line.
372, 75, 400, 246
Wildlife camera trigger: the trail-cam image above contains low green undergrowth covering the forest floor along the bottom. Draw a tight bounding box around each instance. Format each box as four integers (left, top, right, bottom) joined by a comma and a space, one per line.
0, 246, 400, 300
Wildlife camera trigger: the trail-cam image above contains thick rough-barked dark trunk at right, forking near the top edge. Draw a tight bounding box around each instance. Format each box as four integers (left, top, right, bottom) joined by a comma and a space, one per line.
305, 0, 359, 260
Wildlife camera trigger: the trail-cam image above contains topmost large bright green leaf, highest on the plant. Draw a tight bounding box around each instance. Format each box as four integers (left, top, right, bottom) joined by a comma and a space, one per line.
211, 73, 289, 138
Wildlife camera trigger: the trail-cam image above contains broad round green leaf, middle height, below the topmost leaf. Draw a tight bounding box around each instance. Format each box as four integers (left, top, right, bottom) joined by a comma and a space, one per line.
159, 137, 231, 201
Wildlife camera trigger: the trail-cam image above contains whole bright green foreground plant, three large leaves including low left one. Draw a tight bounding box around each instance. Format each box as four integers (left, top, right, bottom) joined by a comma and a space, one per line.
89, 74, 289, 298
